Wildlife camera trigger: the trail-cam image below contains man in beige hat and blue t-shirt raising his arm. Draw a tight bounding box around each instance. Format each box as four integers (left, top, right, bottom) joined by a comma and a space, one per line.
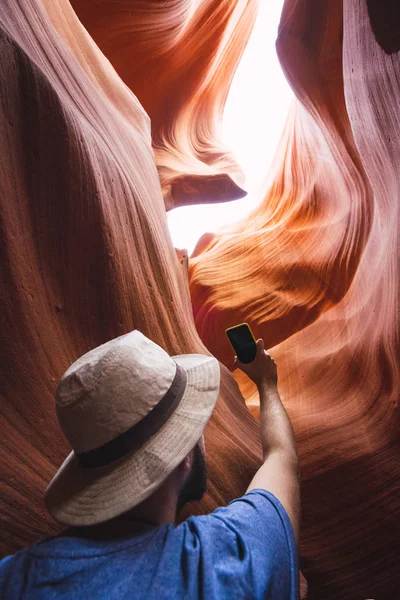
0, 331, 299, 600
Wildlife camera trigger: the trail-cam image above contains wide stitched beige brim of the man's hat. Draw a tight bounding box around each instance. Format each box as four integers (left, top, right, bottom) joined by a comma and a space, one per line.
45, 354, 220, 526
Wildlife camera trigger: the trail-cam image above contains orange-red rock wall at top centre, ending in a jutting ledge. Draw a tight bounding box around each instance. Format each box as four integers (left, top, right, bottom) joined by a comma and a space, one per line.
71, 0, 258, 209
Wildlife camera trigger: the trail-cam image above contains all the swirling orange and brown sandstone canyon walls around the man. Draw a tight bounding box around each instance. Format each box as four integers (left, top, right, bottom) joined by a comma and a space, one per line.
0, 0, 400, 600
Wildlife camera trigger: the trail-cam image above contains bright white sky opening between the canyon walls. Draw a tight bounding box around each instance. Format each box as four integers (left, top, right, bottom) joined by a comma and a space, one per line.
168, 0, 293, 254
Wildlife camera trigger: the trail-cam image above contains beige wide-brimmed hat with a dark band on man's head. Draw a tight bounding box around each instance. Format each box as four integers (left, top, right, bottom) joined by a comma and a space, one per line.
45, 331, 220, 526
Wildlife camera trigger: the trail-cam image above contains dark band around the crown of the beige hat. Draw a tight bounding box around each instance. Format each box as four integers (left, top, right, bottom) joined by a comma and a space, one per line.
76, 364, 187, 469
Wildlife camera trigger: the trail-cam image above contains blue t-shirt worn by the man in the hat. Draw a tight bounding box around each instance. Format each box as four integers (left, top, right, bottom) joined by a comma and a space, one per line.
0, 490, 298, 600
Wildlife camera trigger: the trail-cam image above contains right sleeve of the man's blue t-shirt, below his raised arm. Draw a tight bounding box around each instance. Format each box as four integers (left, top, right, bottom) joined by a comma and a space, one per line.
181, 489, 299, 600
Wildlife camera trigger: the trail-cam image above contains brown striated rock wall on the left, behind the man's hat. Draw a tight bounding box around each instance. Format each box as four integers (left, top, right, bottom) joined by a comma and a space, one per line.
0, 0, 261, 555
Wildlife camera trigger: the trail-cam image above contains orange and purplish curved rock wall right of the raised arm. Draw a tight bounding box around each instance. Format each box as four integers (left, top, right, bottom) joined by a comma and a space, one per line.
190, 0, 400, 599
